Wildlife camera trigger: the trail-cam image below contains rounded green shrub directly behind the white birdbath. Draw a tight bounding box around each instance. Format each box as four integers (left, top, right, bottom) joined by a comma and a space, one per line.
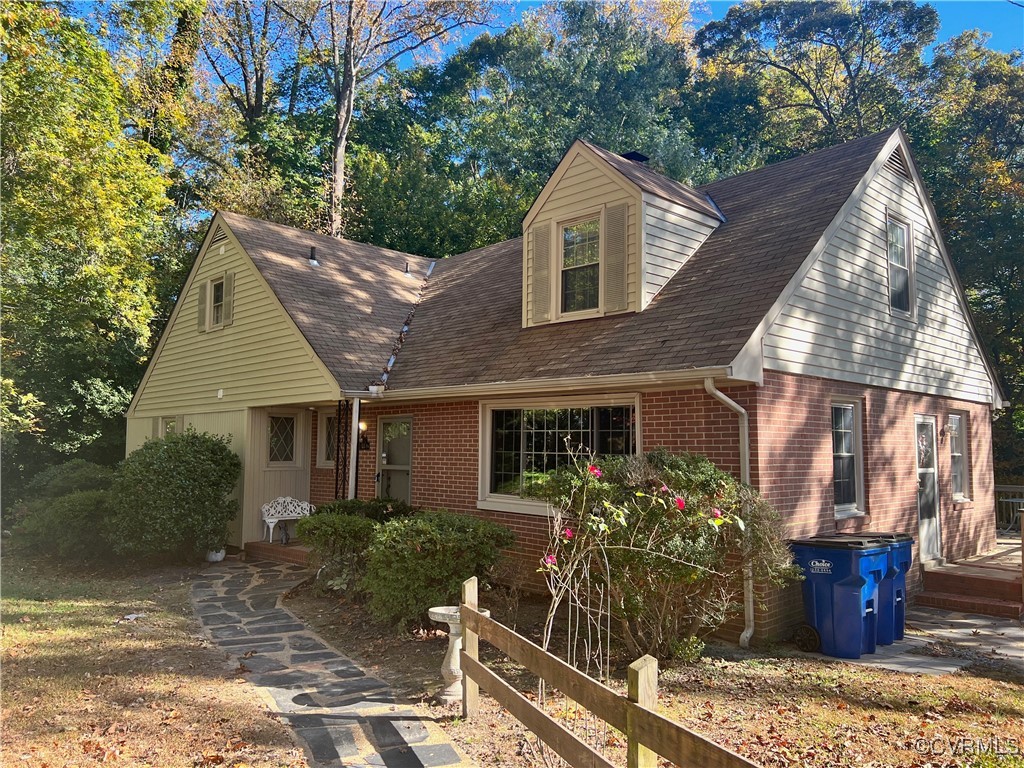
362, 511, 515, 626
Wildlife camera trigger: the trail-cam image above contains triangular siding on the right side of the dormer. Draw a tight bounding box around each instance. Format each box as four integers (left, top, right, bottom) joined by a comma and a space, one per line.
641, 195, 718, 307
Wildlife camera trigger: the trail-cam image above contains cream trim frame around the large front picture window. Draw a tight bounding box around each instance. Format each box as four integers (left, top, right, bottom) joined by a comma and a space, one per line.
476, 392, 643, 515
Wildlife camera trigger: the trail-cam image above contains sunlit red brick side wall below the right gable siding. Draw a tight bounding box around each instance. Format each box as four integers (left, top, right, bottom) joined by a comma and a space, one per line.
752, 372, 995, 637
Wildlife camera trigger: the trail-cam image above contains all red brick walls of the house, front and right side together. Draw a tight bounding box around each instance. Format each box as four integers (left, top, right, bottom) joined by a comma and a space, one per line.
301, 372, 994, 638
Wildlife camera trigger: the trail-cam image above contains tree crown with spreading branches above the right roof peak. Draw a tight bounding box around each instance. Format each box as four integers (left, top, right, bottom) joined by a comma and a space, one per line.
695, 0, 938, 152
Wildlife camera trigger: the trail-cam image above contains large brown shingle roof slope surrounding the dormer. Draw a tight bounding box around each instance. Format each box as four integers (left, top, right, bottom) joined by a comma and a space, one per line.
388, 131, 893, 390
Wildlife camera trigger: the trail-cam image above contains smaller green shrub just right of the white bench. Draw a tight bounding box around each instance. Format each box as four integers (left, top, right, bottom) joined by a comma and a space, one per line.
297, 514, 378, 590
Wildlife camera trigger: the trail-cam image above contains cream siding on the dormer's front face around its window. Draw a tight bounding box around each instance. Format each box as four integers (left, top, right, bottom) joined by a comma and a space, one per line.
523, 152, 640, 326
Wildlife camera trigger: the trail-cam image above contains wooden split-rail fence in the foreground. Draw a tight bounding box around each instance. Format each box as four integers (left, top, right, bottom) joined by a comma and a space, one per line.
460, 578, 757, 768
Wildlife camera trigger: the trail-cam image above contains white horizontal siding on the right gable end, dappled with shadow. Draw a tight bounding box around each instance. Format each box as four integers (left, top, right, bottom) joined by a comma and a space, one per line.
763, 161, 993, 402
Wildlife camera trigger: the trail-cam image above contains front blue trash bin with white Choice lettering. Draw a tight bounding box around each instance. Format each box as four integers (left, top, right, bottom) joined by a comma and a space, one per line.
791, 536, 890, 658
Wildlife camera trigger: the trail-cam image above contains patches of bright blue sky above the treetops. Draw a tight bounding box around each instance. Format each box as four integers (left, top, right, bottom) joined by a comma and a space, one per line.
499, 0, 1024, 52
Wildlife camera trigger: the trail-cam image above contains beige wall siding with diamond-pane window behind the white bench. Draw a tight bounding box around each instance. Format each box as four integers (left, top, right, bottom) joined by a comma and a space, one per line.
241, 409, 312, 542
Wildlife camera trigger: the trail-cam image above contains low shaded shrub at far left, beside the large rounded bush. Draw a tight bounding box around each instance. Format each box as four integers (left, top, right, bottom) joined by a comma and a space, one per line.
13, 490, 111, 560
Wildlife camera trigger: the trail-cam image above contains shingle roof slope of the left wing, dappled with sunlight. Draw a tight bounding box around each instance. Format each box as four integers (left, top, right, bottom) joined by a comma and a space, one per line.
220, 211, 430, 390
